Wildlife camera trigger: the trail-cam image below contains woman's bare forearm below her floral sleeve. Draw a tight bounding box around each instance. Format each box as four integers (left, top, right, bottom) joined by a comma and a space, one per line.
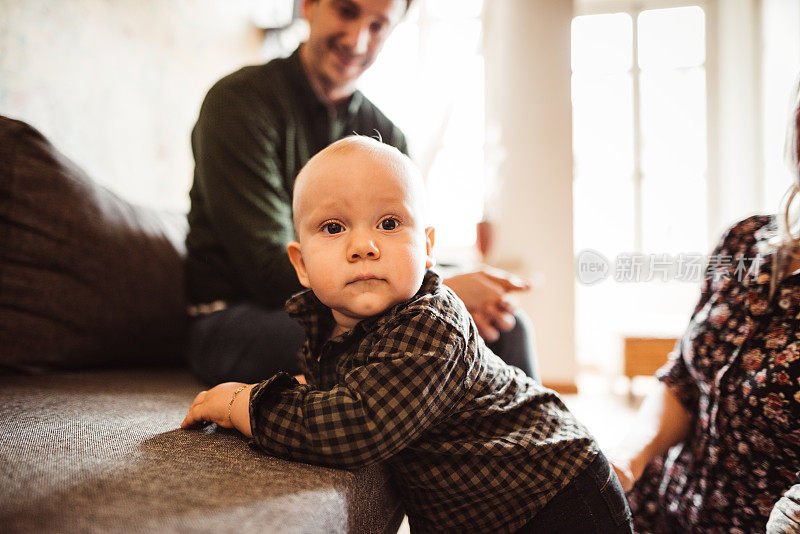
611, 382, 692, 491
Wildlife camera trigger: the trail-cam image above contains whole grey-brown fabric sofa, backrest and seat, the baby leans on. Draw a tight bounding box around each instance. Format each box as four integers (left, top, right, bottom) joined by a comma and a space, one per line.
0, 117, 403, 533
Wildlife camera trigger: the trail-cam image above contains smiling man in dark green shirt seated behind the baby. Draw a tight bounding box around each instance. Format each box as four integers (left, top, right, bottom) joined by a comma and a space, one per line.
186, 0, 536, 383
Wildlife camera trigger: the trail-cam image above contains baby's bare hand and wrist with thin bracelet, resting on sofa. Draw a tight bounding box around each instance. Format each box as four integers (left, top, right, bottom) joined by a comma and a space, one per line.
181, 382, 255, 438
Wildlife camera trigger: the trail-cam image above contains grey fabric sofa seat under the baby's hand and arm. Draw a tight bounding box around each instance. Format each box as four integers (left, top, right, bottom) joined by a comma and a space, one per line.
0, 369, 403, 534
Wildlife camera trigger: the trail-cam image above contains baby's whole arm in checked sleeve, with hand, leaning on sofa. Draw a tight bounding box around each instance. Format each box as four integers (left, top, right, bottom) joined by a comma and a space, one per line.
181, 310, 462, 469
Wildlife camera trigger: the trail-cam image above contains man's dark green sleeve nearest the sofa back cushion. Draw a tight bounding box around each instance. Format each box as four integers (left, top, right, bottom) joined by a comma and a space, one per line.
192, 81, 301, 307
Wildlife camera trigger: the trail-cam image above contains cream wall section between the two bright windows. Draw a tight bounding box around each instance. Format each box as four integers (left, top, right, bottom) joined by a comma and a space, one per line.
484, 0, 576, 385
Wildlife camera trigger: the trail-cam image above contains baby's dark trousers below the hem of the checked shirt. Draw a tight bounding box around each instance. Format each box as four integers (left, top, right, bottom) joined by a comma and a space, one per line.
517, 452, 633, 534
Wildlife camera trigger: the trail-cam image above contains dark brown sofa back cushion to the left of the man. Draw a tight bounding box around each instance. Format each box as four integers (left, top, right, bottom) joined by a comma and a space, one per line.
0, 117, 186, 370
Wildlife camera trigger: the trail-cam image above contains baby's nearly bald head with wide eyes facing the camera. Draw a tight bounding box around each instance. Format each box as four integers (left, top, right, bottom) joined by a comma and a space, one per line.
287, 136, 434, 328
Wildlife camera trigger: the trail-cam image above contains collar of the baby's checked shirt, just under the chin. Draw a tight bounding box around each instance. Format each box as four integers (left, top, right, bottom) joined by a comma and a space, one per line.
286, 270, 442, 354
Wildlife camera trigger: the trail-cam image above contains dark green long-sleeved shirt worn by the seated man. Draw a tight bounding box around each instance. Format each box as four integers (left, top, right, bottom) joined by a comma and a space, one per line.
186, 48, 408, 308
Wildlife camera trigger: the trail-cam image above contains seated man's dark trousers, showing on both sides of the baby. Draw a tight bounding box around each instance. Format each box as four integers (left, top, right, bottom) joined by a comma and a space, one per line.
186, 303, 540, 384
